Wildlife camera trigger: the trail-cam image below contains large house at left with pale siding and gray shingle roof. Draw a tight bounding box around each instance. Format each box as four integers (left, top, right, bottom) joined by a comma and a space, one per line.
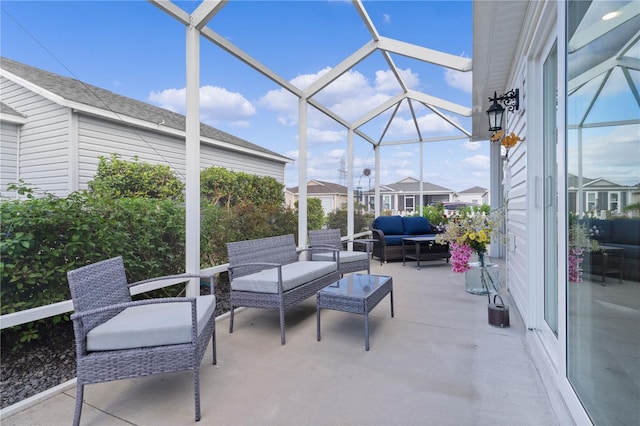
0, 58, 292, 197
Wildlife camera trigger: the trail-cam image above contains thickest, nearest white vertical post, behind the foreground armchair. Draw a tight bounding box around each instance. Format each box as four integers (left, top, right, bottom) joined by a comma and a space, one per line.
185, 18, 200, 297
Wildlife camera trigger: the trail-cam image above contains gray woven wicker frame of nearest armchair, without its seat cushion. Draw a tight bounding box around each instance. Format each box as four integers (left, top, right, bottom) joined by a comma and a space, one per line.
67, 257, 216, 425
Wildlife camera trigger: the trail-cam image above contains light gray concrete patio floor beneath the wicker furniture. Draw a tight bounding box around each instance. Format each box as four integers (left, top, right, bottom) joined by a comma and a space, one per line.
2, 261, 567, 426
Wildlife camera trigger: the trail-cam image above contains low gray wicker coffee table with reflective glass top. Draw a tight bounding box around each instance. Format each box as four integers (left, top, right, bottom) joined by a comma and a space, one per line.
317, 274, 393, 350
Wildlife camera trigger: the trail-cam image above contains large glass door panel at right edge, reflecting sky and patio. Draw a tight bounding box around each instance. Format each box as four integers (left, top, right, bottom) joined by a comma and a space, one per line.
566, 0, 640, 425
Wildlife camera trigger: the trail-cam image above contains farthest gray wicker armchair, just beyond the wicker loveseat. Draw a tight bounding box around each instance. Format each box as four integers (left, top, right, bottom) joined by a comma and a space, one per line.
309, 229, 371, 275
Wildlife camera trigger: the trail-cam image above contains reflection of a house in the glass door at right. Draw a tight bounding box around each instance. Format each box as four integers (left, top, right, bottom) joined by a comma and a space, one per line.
567, 174, 640, 219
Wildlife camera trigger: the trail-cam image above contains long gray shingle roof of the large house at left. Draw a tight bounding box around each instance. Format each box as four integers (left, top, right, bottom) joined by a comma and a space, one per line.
0, 57, 290, 162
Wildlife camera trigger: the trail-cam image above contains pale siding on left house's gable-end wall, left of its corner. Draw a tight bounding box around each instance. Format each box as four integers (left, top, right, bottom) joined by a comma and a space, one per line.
1, 78, 69, 195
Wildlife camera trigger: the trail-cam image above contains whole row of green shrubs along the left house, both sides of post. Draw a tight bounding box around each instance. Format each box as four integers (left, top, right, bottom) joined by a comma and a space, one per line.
0, 161, 296, 349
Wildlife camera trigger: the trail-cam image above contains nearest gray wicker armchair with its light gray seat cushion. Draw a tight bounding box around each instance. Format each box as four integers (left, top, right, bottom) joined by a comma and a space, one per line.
67, 257, 216, 425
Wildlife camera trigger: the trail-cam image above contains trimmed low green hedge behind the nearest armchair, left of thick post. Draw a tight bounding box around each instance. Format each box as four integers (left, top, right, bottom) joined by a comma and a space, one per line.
0, 192, 185, 346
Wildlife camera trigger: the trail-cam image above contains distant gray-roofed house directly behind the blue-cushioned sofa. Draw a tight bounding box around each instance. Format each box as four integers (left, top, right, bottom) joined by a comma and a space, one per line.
363, 177, 455, 215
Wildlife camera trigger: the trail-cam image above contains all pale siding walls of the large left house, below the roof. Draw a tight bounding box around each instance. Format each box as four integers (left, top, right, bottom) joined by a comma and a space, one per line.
0, 77, 286, 196
